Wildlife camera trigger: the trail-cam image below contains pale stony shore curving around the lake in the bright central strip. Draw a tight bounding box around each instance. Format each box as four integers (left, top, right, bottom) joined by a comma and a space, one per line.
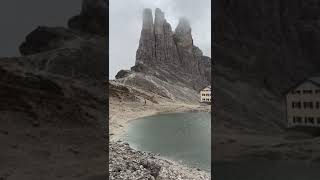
109, 82, 211, 180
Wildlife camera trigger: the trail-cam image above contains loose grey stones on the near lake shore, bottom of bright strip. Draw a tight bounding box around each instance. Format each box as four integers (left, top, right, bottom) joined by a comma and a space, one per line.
109, 141, 211, 180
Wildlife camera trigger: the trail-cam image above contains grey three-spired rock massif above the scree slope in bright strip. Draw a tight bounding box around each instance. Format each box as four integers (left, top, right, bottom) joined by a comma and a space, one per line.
136, 8, 211, 90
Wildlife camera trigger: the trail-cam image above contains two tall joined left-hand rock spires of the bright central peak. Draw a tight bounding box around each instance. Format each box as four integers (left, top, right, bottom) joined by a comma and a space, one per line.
136, 8, 179, 66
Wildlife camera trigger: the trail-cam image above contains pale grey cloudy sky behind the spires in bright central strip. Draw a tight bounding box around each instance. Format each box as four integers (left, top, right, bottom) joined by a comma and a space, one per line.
109, 0, 211, 79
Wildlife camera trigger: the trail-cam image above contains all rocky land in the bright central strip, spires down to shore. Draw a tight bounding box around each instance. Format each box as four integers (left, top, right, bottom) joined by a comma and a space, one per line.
109, 8, 211, 179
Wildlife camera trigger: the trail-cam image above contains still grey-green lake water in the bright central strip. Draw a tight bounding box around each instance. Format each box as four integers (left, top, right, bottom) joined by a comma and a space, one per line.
125, 112, 211, 171
